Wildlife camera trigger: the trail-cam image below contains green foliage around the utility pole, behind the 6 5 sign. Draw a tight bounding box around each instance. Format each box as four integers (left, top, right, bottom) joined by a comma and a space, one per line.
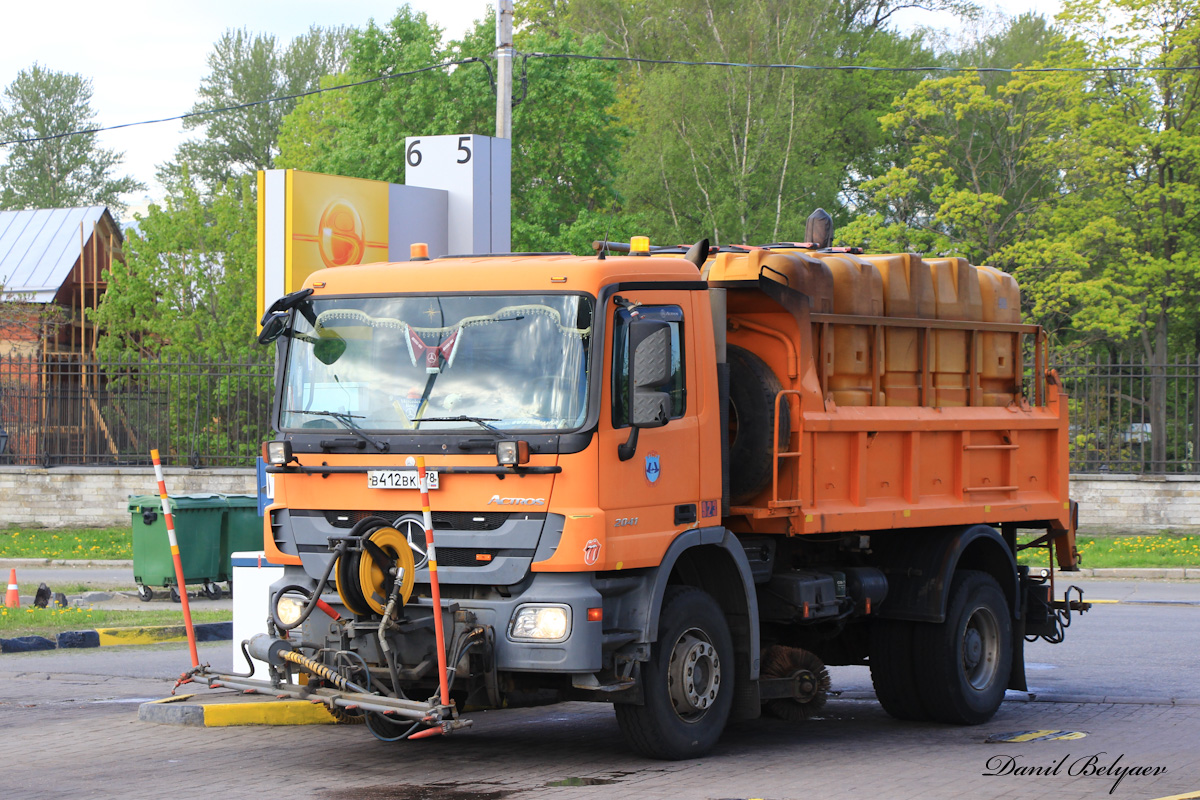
277, 6, 624, 249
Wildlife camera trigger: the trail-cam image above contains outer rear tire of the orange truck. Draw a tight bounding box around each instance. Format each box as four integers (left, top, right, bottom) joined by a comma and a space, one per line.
913, 570, 1013, 724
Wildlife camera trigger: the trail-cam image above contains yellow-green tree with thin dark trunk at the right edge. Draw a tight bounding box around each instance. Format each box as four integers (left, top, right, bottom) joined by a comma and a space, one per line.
1013, 0, 1200, 468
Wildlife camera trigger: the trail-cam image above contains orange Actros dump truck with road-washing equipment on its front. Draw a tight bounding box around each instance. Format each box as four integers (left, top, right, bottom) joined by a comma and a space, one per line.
200, 224, 1086, 758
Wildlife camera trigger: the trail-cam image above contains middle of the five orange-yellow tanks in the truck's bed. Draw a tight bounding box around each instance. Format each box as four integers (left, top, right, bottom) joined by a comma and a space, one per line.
860, 253, 936, 405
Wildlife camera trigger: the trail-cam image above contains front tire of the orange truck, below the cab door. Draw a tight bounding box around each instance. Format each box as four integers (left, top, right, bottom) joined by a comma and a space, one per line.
614, 587, 733, 760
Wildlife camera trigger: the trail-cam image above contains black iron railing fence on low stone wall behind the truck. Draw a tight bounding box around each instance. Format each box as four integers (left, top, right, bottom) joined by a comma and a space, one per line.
0, 354, 1200, 474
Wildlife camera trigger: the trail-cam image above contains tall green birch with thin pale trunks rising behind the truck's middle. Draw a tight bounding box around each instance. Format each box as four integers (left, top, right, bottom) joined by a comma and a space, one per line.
571, 0, 931, 242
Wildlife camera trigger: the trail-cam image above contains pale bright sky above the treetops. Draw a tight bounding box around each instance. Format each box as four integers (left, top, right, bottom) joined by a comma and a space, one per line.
0, 0, 1058, 211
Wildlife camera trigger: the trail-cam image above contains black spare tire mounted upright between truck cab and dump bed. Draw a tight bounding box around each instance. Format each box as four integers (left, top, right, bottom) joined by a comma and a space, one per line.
726, 344, 791, 505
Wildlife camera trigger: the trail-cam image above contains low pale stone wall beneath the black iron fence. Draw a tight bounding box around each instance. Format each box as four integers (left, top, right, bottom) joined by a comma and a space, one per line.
0, 467, 1200, 534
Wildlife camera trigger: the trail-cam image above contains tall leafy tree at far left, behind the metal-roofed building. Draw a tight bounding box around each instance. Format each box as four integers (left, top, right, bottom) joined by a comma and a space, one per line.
0, 64, 145, 216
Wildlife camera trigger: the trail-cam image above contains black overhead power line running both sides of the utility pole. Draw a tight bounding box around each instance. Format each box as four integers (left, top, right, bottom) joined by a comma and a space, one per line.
0, 53, 1200, 148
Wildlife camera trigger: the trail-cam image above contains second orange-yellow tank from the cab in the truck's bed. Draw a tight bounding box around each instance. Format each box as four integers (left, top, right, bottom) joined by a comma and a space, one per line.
812, 253, 883, 405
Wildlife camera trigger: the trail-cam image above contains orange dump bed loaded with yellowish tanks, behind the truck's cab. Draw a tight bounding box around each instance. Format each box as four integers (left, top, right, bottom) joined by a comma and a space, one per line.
706, 249, 1070, 534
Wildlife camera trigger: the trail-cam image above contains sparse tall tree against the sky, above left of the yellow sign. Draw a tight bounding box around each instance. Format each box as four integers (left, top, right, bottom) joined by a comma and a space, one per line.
172, 26, 349, 187
